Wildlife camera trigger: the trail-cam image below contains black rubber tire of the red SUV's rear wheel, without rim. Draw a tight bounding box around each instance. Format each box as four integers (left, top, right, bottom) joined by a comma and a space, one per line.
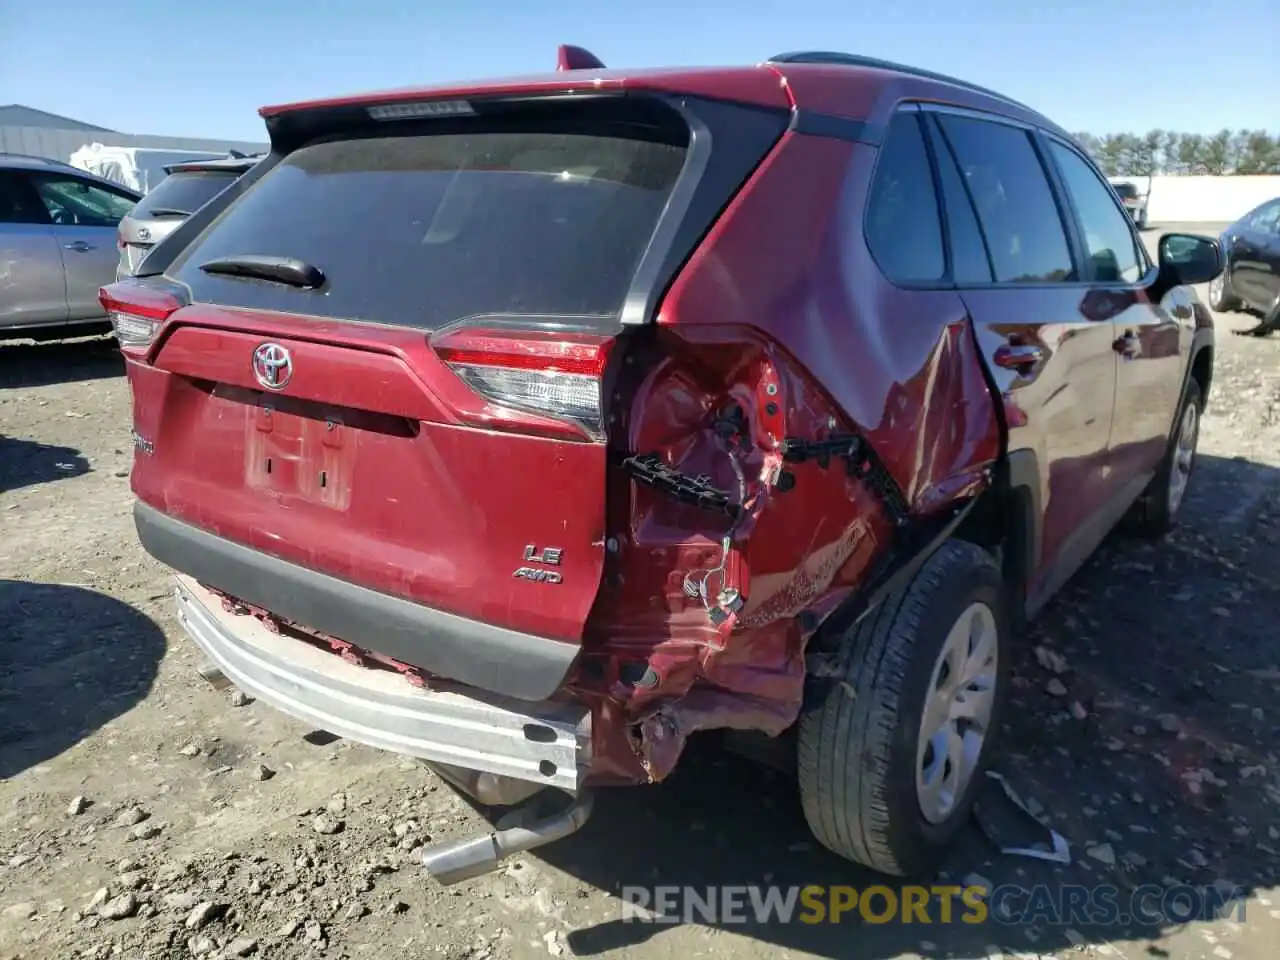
797, 540, 1009, 877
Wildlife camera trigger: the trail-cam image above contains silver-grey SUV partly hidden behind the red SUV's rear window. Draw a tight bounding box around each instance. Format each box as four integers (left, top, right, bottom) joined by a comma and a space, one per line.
115, 156, 261, 279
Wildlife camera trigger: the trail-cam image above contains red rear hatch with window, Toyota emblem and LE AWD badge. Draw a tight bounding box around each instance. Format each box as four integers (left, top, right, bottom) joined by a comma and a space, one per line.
111, 88, 788, 675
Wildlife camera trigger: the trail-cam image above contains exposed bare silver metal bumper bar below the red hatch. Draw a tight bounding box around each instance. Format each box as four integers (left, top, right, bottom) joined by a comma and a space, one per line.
177, 576, 591, 792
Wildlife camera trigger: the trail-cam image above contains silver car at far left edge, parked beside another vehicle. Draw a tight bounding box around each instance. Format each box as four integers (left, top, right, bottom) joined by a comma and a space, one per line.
0, 154, 141, 338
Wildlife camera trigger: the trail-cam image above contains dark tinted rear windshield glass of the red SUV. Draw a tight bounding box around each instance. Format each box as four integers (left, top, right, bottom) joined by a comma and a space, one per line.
166, 132, 685, 330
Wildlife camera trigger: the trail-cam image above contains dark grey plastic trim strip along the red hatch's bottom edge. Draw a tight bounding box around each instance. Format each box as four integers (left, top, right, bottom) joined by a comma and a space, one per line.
133, 500, 580, 701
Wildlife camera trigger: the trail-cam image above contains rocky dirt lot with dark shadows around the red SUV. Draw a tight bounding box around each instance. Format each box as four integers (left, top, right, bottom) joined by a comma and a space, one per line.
0, 225, 1280, 960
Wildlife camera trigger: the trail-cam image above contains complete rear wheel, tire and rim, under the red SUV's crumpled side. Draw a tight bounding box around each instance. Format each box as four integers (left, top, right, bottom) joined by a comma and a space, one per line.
797, 540, 1009, 877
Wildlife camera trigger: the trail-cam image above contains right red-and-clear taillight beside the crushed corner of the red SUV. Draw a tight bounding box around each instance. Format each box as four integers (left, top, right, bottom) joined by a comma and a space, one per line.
431, 329, 613, 440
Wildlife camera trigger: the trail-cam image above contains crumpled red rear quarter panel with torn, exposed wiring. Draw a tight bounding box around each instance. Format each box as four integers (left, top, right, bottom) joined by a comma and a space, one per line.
586, 134, 1000, 781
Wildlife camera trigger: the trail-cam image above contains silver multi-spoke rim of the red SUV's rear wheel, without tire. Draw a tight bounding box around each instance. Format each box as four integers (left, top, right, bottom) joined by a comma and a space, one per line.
915, 603, 1000, 823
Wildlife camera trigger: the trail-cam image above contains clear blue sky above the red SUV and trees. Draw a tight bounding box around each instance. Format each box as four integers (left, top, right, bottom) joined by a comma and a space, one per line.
0, 0, 1280, 140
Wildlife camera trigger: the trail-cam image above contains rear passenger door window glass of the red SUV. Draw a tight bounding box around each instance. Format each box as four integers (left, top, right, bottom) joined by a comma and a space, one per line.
938, 116, 1076, 283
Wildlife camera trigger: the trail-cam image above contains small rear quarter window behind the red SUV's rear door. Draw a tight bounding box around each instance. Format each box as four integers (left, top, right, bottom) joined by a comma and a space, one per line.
865, 113, 946, 283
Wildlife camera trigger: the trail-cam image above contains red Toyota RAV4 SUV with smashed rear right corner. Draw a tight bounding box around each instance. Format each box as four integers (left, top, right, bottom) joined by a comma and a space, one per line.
102, 50, 1222, 883
